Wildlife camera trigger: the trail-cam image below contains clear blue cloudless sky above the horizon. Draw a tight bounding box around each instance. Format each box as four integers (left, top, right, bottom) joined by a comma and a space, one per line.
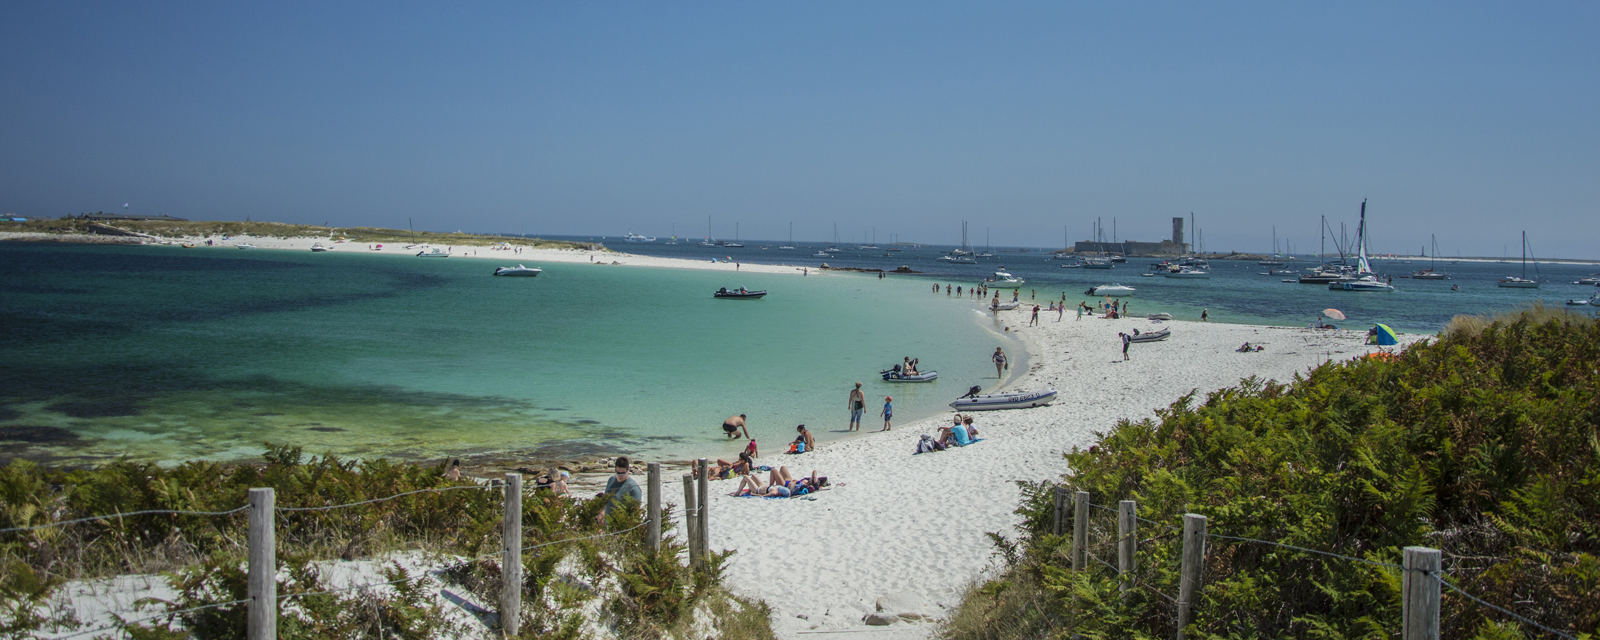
0, 2, 1600, 258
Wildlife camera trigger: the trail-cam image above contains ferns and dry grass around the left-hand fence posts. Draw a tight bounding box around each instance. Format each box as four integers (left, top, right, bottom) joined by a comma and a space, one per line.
0, 446, 771, 640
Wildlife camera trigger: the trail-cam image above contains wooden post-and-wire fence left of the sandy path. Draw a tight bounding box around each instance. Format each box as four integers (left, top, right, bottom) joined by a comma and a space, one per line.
0, 459, 709, 640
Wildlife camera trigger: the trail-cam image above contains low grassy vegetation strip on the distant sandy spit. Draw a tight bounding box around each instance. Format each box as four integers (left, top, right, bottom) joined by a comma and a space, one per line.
0, 218, 590, 250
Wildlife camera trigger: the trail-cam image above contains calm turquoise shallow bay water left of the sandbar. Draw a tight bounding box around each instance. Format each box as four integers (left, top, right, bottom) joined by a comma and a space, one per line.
0, 243, 1021, 462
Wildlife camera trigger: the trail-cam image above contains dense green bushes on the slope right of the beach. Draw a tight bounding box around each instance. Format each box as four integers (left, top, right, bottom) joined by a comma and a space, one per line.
942, 307, 1600, 640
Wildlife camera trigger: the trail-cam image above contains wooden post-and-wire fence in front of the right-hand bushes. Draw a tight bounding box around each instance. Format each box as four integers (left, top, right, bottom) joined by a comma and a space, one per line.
1053, 486, 1578, 640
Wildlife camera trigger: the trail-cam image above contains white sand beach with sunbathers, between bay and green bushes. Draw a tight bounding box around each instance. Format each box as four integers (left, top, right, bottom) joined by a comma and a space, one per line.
681, 310, 1421, 638
